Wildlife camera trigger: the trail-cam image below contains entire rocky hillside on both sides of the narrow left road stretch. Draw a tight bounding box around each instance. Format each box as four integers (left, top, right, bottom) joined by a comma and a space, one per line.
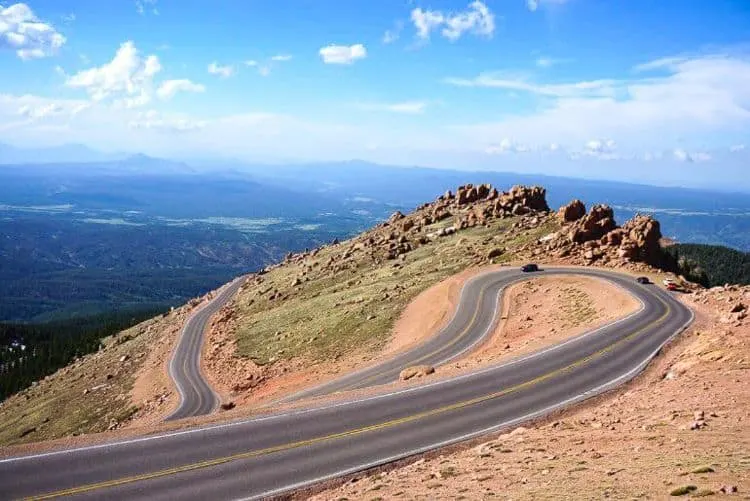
0, 184, 680, 444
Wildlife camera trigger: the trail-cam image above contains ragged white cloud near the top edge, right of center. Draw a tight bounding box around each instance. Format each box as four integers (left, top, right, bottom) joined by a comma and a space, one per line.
411, 0, 495, 41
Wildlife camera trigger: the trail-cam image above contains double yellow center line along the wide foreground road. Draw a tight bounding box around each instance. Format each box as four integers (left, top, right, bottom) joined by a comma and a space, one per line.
27, 295, 672, 500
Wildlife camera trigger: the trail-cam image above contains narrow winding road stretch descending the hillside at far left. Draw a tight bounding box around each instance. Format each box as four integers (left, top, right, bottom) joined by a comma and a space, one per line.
166, 277, 242, 421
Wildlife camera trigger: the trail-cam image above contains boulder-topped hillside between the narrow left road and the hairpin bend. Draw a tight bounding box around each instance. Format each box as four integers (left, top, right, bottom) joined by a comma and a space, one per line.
205, 184, 676, 407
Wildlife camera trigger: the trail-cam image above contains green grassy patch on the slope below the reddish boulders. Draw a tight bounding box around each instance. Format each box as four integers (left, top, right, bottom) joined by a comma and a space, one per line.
235, 213, 558, 364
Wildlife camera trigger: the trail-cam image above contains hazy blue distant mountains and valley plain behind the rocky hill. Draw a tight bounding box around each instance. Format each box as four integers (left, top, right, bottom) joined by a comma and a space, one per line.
0, 145, 750, 320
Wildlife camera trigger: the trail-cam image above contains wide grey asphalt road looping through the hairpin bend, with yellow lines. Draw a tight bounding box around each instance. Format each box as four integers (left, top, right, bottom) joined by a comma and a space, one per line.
0, 270, 693, 499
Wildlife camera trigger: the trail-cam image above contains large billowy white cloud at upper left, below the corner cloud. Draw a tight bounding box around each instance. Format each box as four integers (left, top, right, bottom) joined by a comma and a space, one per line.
65, 41, 161, 108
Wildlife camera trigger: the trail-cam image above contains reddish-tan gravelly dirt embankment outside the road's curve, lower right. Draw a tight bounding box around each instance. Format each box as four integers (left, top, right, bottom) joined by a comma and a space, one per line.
312, 287, 750, 500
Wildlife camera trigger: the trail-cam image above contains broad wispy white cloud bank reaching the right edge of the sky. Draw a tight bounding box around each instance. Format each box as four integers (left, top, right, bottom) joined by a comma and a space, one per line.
447, 54, 750, 151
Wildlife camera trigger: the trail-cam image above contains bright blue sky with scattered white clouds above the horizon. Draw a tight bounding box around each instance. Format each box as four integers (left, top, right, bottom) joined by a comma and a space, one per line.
0, 0, 750, 191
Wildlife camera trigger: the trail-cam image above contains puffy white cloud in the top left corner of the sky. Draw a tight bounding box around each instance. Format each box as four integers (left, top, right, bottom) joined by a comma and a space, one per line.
0, 3, 66, 59
